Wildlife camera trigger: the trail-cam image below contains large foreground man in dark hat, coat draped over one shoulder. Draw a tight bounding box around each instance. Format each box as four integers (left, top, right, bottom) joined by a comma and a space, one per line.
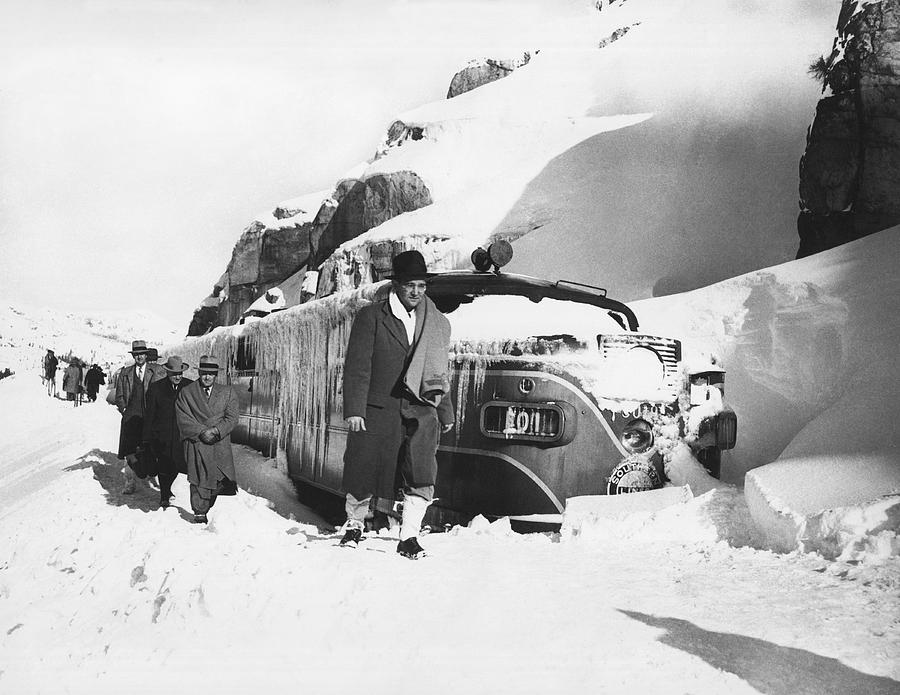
341, 251, 454, 558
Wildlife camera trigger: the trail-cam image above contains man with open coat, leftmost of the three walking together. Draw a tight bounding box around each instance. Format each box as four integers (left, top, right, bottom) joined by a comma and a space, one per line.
116, 340, 166, 495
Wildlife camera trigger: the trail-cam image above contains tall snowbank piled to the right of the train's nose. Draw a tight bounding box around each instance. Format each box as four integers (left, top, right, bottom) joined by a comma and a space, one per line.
633, 227, 900, 559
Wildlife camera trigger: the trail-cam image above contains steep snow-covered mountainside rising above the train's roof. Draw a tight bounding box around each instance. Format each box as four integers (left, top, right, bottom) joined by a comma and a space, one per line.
312, 0, 837, 300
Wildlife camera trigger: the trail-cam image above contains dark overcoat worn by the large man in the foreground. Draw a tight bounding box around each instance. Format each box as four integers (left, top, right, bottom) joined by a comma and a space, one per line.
342, 299, 453, 500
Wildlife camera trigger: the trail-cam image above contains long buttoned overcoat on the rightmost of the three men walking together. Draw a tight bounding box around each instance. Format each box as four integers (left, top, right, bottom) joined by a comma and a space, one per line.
175, 381, 239, 490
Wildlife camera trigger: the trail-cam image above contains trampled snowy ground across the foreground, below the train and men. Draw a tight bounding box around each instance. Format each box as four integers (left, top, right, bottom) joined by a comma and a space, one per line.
0, 371, 900, 695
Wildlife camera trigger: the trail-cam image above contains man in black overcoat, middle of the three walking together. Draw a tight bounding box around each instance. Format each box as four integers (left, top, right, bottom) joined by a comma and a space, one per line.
142, 355, 193, 509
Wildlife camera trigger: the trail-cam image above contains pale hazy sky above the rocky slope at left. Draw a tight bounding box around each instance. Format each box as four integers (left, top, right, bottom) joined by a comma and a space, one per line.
0, 0, 584, 325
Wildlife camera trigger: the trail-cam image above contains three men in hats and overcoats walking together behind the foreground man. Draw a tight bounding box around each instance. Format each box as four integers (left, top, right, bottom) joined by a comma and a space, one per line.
115, 340, 238, 523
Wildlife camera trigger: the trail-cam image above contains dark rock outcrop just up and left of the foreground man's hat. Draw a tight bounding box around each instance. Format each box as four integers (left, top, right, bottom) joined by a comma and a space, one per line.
309, 171, 433, 267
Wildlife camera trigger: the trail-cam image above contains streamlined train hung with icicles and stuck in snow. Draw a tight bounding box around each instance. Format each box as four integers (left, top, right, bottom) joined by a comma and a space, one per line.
184, 242, 737, 525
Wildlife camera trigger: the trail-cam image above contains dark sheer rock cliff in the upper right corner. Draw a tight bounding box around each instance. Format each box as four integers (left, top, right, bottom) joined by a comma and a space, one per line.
797, 0, 900, 258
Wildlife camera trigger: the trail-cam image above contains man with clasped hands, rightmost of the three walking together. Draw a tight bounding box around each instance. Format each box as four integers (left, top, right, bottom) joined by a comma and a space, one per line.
175, 355, 239, 524
